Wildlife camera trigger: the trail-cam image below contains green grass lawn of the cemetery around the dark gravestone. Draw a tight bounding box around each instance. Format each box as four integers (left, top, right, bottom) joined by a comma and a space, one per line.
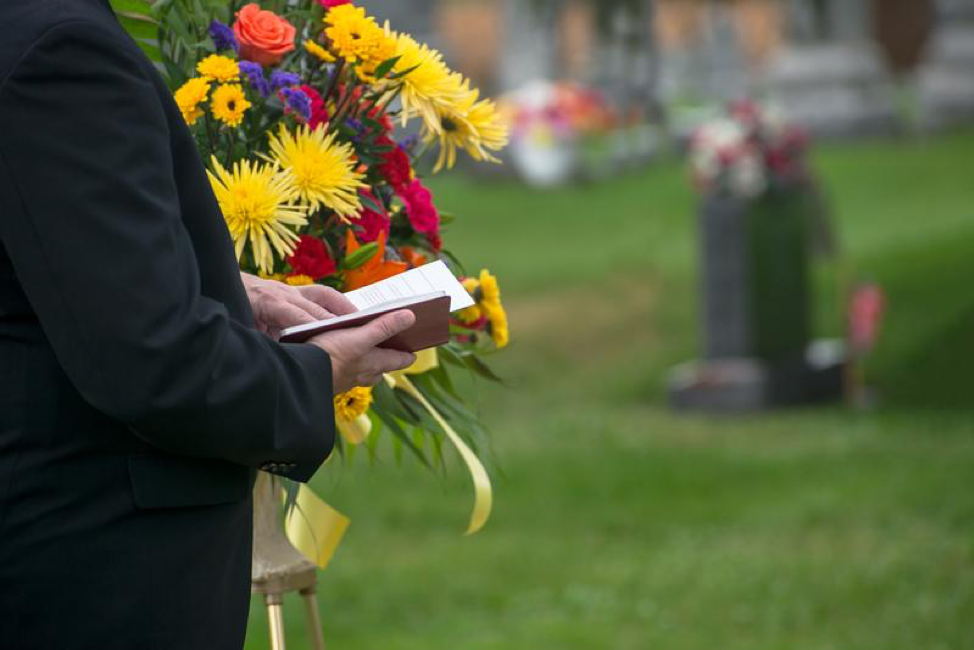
247, 133, 974, 650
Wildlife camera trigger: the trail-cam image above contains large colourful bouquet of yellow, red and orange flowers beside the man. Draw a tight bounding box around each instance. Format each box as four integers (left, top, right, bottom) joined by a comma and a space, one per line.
122, 0, 509, 529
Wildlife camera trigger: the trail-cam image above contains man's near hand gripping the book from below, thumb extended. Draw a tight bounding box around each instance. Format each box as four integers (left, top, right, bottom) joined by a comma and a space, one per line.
308, 310, 416, 395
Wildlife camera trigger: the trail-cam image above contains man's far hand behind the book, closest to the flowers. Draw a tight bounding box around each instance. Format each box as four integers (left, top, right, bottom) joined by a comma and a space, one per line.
240, 273, 356, 339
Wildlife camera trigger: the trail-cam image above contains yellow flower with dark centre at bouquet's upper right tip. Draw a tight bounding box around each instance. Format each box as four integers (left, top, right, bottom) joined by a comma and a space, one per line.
426, 90, 507, 173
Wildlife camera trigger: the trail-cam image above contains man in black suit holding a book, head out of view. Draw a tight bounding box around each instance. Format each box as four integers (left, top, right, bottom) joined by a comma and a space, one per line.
0, 0, 412, 650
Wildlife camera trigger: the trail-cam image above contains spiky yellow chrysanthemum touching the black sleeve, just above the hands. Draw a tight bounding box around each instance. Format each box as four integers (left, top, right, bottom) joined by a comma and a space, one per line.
207, 156, 308, 273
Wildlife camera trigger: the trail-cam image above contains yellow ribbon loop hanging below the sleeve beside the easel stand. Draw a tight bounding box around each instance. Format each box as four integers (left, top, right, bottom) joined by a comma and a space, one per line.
284, 485, 350, 569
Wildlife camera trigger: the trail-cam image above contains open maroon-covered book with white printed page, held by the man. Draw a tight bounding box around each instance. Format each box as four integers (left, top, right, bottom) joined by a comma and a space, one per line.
281, 262, 474, 352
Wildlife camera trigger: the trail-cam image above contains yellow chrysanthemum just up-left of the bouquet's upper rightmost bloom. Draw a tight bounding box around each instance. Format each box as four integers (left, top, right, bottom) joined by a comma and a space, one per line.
393, 34, 470, 133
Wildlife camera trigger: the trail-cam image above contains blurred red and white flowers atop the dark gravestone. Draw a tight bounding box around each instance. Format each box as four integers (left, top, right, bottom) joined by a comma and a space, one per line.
690, 101, 809, 198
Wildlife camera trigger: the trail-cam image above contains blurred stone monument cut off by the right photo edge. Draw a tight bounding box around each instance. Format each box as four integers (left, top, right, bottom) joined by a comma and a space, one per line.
919, 0, 974, 127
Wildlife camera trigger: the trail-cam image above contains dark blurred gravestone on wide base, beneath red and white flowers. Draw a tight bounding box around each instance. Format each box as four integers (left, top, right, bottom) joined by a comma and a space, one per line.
670, 191, 842, 411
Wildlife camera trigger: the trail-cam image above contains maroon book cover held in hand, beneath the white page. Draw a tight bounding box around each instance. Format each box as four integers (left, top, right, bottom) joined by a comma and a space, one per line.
281, 291, 450, 352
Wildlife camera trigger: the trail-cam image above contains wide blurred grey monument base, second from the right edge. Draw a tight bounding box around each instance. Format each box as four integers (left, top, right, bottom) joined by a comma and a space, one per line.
767, 0, 896, 135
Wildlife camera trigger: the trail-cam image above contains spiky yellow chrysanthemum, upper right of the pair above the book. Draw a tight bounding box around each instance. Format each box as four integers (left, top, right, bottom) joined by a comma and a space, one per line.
270, 124, 365, 219
